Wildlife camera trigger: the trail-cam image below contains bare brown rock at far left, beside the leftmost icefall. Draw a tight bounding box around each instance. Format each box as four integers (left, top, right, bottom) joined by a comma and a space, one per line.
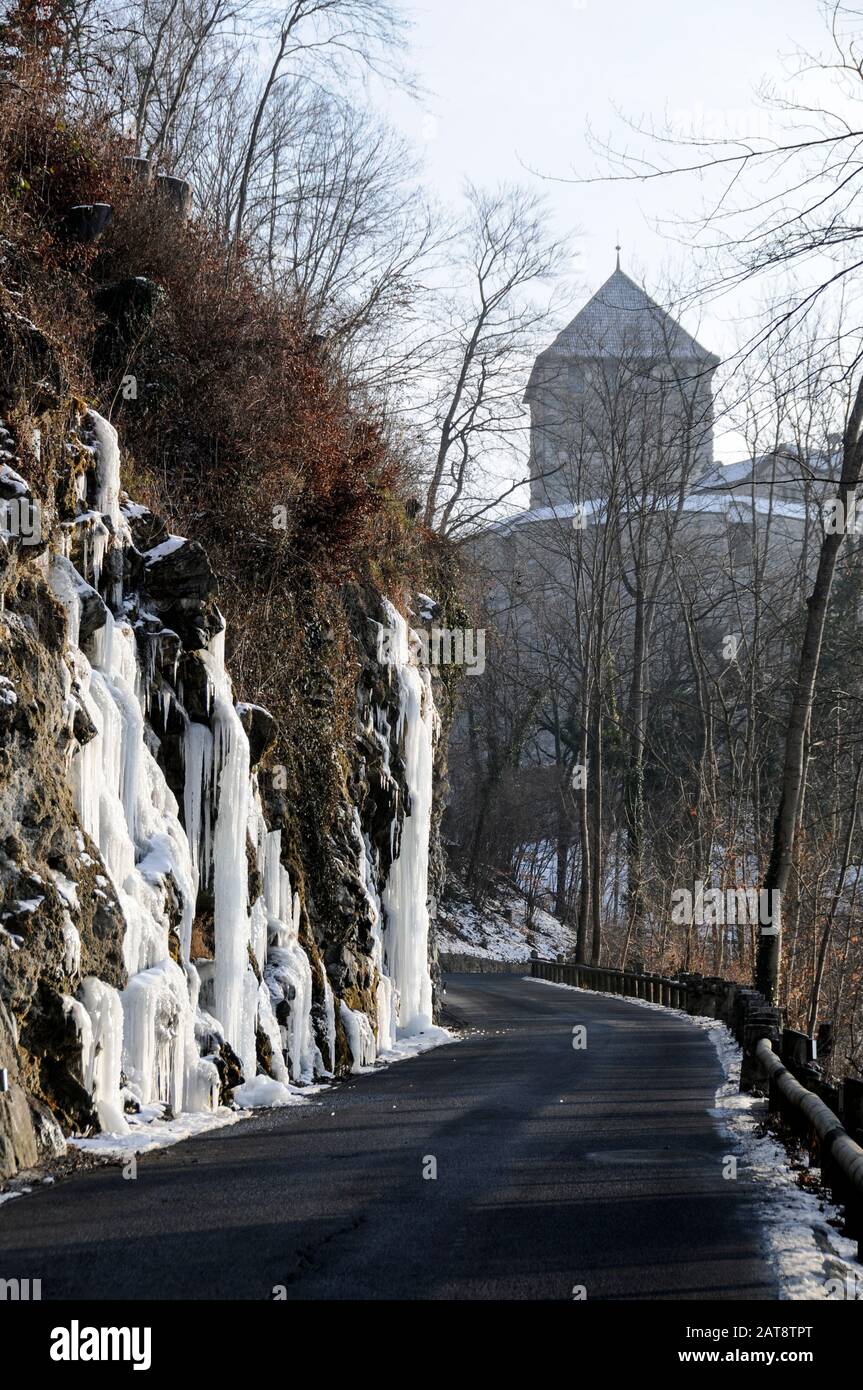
0, 483, 125, 1162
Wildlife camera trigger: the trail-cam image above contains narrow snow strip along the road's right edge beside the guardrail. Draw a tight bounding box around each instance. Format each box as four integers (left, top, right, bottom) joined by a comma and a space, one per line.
525, 976, 863, 1301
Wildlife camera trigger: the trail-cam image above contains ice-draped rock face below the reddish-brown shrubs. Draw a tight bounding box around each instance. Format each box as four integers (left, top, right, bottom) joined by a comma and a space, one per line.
0, 378, 442, 1176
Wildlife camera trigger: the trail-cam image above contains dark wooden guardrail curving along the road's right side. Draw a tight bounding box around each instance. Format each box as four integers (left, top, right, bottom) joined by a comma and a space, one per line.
531, 959, 863, 1259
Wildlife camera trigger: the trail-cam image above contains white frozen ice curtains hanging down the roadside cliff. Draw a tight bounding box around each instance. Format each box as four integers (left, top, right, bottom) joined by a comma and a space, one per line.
25, 411, 450, 1152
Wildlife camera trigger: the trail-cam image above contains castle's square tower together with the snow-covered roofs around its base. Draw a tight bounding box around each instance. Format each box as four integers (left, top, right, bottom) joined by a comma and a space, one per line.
478, 260, 837, 570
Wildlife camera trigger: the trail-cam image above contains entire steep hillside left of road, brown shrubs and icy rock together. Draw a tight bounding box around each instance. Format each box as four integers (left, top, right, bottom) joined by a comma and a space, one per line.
0, 32, 454, 1176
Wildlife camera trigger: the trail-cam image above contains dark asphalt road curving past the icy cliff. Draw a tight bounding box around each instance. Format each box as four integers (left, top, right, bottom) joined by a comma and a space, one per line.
0, 976, 777, 1300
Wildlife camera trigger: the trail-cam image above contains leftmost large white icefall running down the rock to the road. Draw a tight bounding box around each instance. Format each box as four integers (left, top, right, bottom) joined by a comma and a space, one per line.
56, 489, 205, 1133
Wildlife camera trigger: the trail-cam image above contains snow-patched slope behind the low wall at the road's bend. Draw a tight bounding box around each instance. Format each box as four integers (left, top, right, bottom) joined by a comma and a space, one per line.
436, 885, 575, 960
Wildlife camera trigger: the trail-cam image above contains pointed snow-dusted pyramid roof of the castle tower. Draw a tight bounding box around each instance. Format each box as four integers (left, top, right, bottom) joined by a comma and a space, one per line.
538, 265, 718, 367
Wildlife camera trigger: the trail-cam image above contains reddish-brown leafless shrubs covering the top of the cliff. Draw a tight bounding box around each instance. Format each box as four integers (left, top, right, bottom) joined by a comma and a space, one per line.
0, 0, 425, 580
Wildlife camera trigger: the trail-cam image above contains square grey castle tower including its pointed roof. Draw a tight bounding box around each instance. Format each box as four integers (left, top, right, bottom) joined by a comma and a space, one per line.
524, 259, 718, 509
